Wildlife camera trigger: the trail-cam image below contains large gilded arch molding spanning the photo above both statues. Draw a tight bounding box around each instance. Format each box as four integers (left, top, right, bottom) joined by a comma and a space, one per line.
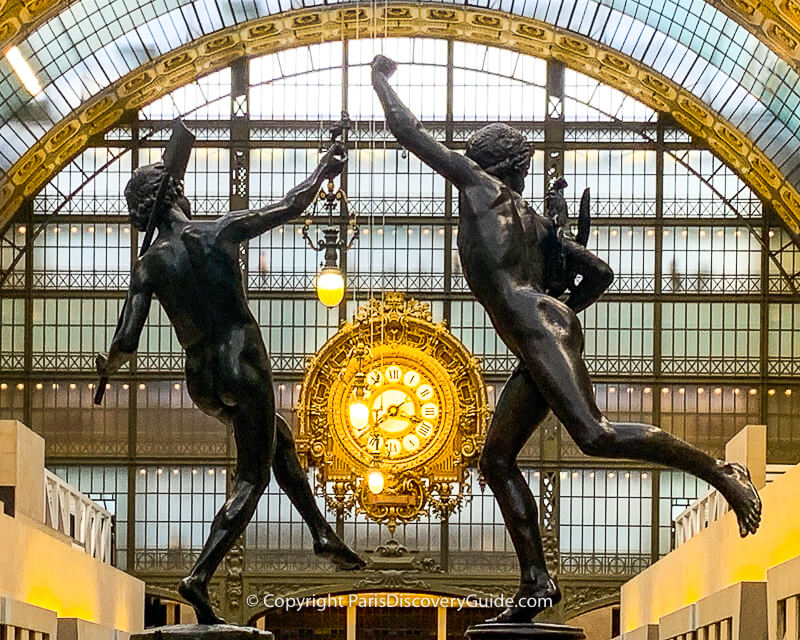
0, 0, 800, 232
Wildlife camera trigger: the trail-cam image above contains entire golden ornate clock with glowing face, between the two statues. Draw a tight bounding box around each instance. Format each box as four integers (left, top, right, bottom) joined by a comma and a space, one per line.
297, 293, 489, 527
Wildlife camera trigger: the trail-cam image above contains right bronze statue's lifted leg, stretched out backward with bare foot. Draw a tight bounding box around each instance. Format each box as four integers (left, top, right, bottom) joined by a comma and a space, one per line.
512, 293, 761, 536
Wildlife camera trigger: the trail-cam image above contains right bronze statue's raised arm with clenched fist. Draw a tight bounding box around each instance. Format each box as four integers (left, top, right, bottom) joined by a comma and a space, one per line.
372, 56, 485, 189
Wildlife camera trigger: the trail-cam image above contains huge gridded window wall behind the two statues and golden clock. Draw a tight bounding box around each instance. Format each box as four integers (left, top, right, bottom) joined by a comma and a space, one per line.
0, 38, 800, 574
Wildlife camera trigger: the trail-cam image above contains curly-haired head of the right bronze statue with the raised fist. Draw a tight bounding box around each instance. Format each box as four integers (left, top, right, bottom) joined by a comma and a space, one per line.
467, 122, 531, 193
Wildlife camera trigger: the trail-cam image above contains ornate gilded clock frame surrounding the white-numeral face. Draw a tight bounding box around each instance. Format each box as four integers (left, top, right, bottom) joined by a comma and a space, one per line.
296, 292, 490, 528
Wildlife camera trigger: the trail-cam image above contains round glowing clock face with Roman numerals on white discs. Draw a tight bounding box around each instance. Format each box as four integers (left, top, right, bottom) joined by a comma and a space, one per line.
347, 363, 442, 462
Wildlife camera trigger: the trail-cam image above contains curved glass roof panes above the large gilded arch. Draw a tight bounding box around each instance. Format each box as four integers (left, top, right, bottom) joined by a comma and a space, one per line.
0, 0, 800, 186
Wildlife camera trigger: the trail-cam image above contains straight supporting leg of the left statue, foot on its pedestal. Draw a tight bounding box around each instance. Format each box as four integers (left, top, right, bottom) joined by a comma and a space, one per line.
178, 396, 275, 624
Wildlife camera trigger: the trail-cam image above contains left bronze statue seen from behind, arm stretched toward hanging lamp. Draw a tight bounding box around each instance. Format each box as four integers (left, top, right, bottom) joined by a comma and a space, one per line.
97, 143, 365, 624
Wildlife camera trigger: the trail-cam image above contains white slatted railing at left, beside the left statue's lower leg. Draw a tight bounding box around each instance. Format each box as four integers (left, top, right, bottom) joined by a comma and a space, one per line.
44, 469, 113, 564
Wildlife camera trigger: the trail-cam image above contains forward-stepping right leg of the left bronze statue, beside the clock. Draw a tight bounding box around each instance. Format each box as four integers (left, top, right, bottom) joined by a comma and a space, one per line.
272, 414, 367, 569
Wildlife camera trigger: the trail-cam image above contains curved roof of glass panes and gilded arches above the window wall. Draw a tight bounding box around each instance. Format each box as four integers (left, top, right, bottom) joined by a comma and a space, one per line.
0, 0, 800, 230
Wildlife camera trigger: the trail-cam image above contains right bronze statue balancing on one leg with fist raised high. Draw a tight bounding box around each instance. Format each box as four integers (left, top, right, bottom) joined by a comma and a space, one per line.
372, 56, 761, 623
